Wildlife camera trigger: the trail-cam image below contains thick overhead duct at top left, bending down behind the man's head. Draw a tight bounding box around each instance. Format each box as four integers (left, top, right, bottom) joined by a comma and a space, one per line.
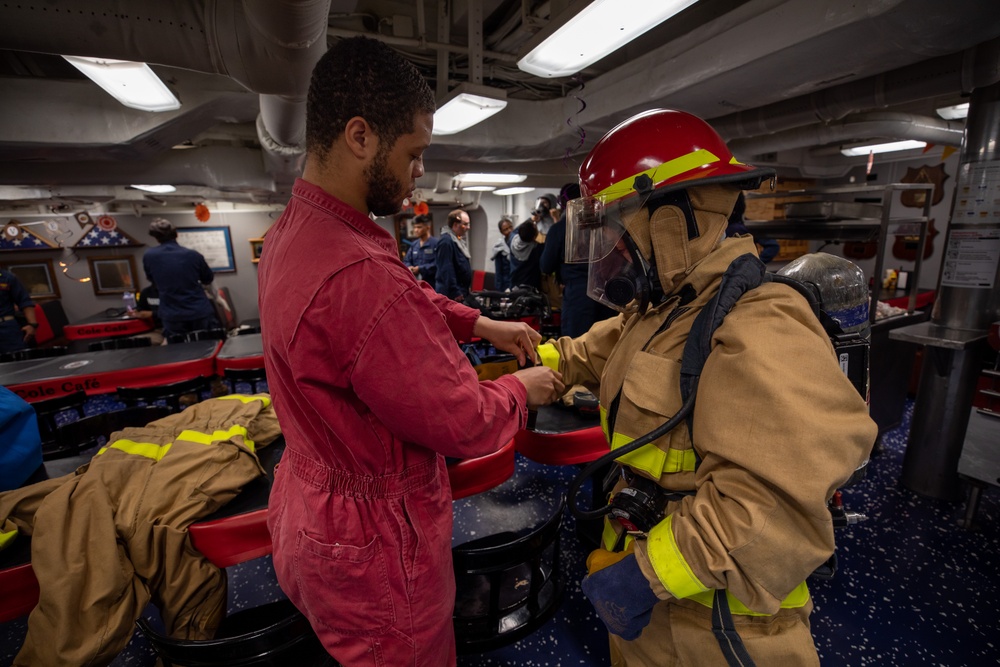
0, 0, 330, 179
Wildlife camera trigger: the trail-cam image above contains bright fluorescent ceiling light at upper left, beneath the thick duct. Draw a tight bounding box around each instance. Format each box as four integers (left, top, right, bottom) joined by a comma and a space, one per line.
63, 56, 181, 111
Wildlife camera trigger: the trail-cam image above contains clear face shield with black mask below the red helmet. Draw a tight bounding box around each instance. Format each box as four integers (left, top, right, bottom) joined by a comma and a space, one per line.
566, 189, 649, 313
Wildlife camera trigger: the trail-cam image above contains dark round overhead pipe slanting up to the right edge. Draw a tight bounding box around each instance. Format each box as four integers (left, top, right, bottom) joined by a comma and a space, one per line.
709, 38, 1000, 141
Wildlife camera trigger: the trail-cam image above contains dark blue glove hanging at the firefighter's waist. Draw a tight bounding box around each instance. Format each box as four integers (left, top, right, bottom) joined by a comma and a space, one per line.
581, 554, 659, 641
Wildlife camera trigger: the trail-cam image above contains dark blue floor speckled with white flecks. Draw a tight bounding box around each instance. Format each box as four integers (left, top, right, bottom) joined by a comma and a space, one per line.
0, 404, 1000, 667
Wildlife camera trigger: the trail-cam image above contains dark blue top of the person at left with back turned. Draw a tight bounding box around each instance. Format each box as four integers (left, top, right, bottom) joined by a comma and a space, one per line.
142, 241, 215, 322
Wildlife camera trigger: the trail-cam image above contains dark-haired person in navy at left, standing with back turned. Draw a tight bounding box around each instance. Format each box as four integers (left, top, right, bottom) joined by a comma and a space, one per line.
142, 218, 221, 341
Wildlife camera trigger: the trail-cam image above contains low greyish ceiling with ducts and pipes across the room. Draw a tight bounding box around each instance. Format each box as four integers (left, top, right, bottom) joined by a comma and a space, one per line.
0, 0, 1000, 211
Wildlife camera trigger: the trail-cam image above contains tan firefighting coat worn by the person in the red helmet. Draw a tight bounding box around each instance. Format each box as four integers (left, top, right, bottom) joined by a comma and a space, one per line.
540, 237, 877, 664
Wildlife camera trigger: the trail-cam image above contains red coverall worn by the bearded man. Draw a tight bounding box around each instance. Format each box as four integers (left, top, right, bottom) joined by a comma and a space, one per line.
259, 180, 527, 667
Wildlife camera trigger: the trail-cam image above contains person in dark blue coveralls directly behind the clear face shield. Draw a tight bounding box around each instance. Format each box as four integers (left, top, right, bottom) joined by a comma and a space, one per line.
539, 183, 616, 338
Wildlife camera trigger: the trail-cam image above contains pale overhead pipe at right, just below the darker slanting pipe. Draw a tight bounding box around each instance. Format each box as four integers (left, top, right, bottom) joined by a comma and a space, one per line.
729, 111, 964, 161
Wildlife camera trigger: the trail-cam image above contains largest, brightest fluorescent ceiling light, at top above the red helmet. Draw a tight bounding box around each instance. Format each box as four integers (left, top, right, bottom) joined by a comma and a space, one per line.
517, 0, 697, 77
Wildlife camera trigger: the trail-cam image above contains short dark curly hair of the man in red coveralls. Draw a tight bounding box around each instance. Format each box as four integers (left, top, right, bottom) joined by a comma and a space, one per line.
306, 37, 437, 160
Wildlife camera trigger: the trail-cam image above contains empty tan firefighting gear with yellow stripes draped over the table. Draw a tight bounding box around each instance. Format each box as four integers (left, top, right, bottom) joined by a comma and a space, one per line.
0, 394, 281, 667
